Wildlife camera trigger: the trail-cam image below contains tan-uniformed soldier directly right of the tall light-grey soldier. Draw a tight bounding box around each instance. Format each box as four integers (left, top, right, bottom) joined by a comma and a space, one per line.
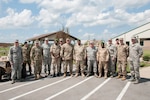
50, 40, 61, 77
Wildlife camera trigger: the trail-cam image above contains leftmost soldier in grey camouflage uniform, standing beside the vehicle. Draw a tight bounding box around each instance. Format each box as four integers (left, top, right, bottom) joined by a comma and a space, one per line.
9, 40, 23, 84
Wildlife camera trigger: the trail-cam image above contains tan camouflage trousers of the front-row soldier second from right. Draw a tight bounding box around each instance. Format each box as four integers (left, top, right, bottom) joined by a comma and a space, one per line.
118, 60, 127, 76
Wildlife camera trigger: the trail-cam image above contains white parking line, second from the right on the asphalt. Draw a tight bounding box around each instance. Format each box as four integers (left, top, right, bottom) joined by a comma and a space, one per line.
81, 78, 111, 100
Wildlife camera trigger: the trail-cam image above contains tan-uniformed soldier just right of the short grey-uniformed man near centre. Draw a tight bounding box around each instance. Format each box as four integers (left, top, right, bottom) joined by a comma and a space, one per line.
97, 42, 109, 79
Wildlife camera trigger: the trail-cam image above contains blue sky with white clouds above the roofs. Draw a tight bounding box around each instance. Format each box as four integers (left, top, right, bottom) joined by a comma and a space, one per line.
0, 0, 150, 43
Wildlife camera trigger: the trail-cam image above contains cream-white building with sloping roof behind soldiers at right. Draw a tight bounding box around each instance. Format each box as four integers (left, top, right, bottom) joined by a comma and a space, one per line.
112, 22, 150, 50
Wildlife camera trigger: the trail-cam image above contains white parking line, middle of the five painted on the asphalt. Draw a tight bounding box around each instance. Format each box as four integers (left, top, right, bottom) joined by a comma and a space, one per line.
45, 76, 93, 100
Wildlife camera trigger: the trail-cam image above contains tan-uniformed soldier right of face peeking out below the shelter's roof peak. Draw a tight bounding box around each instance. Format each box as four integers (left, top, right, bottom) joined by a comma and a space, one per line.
61, 38, 73, 77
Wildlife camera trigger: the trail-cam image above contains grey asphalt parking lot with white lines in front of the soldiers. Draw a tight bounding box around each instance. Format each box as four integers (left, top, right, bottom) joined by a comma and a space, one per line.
0, 67, 150, 100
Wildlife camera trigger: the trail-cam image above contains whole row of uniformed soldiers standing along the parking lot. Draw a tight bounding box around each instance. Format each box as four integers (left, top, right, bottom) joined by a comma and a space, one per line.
9, 37, 143, 84
